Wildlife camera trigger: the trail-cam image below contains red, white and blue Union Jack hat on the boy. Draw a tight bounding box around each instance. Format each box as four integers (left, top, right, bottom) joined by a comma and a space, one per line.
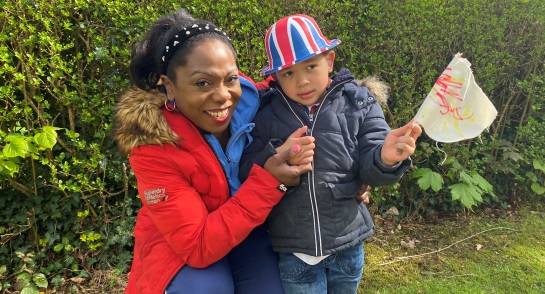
260, 14, 341, 76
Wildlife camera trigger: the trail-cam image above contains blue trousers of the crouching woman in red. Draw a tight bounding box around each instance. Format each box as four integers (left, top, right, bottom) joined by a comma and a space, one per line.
165, 225, 284, 294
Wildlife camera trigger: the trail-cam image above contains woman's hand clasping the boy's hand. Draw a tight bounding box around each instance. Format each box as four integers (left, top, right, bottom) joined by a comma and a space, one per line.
263, 145, 312, 186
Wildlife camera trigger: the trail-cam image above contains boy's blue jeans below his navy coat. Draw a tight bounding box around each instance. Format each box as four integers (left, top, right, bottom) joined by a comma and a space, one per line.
278, 242, 364, 294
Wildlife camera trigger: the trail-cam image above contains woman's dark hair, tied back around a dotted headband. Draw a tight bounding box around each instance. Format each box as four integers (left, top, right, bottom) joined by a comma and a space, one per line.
129, 9, 236, 90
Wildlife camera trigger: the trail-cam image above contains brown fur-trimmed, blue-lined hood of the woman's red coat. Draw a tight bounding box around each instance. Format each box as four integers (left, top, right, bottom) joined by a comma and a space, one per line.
112, 77, 259, 154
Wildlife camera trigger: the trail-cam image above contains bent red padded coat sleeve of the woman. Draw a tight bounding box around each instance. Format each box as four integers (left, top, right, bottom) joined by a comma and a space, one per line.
129, 145, 283, 268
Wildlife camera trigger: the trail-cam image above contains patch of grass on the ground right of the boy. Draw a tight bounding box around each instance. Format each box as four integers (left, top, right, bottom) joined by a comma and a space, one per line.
358, 202, 545, 293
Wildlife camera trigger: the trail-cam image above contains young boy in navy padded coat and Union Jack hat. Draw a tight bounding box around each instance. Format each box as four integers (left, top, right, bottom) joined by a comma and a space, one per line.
240, 14, 422, 294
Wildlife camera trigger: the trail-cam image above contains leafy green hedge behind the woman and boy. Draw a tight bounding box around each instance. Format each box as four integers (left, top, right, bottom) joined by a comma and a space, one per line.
0, 0, 545, 291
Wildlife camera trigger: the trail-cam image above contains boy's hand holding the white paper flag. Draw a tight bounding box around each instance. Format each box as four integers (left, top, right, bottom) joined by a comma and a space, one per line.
380, 120, 422, 166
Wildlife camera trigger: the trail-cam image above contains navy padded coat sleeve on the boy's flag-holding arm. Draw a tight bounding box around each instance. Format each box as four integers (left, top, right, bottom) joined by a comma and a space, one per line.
358, 102, 411, 187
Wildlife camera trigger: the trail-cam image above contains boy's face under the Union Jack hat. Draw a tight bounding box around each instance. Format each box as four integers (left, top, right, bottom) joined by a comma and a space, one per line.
275, 50, 335, 106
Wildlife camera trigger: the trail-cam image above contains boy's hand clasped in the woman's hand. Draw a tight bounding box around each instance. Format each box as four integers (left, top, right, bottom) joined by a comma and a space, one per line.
276, 126, 315, 165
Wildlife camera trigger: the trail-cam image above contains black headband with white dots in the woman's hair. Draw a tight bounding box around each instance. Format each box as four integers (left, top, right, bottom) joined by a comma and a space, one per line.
161, 24, 231, 74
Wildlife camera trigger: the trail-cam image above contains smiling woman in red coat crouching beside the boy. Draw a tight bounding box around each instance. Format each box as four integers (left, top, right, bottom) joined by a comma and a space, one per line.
114, 10, 314, 293
